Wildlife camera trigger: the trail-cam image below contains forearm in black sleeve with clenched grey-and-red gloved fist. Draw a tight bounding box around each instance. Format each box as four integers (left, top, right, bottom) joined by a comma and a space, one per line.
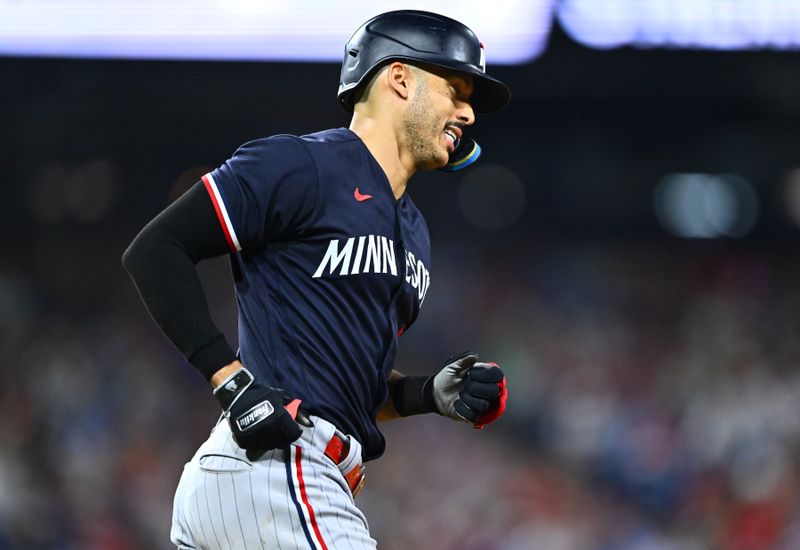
377, 352, 508, 428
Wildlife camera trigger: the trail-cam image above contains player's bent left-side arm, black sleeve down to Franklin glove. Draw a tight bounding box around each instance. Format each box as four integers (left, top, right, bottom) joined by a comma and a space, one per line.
122, 183, 301, 450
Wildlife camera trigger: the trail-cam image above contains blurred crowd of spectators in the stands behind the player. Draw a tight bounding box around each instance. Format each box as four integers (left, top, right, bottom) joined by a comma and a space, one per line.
0, 235, 800, 550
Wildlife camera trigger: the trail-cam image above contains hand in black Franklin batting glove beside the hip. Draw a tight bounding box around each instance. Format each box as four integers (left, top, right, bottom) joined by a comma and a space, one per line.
214, 368, 302, 451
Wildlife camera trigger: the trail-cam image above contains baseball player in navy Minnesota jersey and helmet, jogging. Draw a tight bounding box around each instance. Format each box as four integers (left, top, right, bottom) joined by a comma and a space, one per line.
123, 10, 510, 550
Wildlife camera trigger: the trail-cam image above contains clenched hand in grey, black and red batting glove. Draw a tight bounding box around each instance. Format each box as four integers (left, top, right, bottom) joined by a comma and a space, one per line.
433, 352, 508, 428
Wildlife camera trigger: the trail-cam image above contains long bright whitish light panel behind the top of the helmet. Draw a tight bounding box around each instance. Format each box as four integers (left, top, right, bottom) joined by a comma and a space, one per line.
0, 0, 554, 62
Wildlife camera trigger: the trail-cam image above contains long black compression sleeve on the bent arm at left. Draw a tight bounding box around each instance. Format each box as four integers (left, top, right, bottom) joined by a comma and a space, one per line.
122, 182, 236, 379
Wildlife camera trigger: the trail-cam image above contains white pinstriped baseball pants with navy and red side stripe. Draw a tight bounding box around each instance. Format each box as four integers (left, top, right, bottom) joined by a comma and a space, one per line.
171, 416, 376, 550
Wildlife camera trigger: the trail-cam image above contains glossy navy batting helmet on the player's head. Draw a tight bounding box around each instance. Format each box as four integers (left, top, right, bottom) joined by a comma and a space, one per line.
338, 10, 511, 113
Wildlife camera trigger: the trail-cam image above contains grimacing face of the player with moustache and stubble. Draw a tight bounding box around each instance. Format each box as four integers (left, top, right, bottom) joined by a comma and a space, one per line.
403, 69, 475, 170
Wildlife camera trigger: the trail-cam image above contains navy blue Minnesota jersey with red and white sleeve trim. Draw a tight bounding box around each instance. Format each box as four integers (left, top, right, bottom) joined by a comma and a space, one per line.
203, 128, 430, 460
